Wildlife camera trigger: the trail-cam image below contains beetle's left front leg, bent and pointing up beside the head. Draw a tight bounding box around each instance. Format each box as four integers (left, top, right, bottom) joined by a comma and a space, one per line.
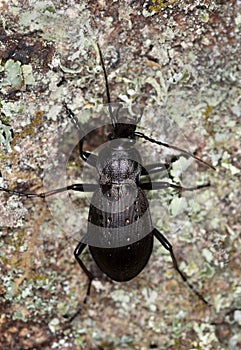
63, 102, 97, 167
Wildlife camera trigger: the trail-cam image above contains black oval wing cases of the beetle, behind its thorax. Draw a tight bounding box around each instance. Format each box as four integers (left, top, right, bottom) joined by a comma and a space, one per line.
87, 184, 153, 281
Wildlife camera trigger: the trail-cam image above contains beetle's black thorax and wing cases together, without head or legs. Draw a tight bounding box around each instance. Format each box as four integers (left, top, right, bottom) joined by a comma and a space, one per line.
85, 135, 153, 281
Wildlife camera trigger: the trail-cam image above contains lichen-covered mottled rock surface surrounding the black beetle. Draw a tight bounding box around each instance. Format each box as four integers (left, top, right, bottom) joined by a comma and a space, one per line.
0, 1, 241, 350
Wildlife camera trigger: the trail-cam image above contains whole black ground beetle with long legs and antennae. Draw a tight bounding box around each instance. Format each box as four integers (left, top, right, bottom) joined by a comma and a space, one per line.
0, 45, 214, 316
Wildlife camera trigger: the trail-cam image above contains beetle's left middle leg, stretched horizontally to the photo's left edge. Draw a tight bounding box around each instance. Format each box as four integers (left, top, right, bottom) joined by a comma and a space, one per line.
0, 184, 98, 198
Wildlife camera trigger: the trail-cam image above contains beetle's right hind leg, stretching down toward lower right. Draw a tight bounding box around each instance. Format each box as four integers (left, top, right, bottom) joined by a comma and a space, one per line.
153, 228, 211, 306
